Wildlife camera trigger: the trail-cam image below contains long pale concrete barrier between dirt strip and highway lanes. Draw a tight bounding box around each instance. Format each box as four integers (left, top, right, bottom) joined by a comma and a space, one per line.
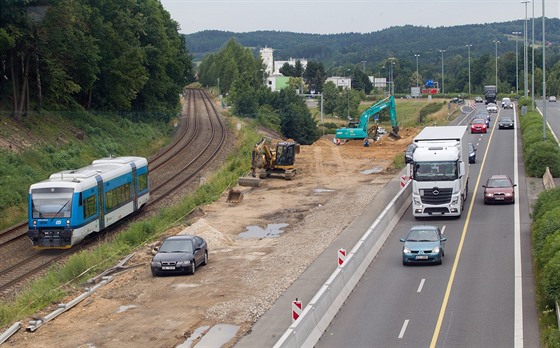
274, 181, 411, 348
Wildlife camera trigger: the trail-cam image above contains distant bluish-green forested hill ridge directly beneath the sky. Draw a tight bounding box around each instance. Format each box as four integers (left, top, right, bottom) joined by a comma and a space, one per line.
186, 18, 560, 68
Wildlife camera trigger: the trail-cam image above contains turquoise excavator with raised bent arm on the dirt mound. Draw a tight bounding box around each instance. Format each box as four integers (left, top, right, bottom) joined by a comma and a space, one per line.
336, 95, 401, 141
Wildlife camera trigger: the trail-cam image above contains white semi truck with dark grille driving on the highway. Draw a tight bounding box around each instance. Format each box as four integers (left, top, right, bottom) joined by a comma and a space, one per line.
411, 126, 469, 218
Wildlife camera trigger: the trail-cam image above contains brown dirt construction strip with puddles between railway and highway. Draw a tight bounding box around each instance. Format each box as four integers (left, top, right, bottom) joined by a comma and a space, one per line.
4, 128, 418, 348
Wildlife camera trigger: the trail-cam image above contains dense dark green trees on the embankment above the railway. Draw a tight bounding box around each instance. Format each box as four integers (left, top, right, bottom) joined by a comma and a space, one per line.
0, 0, 194, 121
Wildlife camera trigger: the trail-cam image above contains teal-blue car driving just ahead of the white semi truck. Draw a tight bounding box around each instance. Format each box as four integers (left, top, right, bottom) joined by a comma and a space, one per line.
401, 225, 447, 266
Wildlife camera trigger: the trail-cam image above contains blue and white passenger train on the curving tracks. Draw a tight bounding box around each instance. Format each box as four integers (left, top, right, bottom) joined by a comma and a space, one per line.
27, 156, 150, 249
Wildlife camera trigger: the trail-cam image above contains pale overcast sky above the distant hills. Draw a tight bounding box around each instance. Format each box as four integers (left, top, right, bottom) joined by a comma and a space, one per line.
160, 0, 560, 34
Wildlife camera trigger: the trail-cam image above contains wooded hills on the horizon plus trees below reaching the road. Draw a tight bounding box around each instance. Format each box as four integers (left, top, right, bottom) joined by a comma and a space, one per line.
186, 18, 560, 96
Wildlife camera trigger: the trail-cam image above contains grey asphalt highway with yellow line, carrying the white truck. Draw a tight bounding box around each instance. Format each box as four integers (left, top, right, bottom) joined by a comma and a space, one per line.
316, 103, 540, 347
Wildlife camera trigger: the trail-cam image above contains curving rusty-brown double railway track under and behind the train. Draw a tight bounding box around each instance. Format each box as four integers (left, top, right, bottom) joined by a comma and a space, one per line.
0, 89, 227, 296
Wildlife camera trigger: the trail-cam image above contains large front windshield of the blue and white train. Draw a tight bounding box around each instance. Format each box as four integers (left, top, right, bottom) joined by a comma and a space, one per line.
31, 187, 74, 219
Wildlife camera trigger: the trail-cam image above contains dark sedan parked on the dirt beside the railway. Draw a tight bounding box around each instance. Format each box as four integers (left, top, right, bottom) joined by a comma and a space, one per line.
150, 235, 208, 277
